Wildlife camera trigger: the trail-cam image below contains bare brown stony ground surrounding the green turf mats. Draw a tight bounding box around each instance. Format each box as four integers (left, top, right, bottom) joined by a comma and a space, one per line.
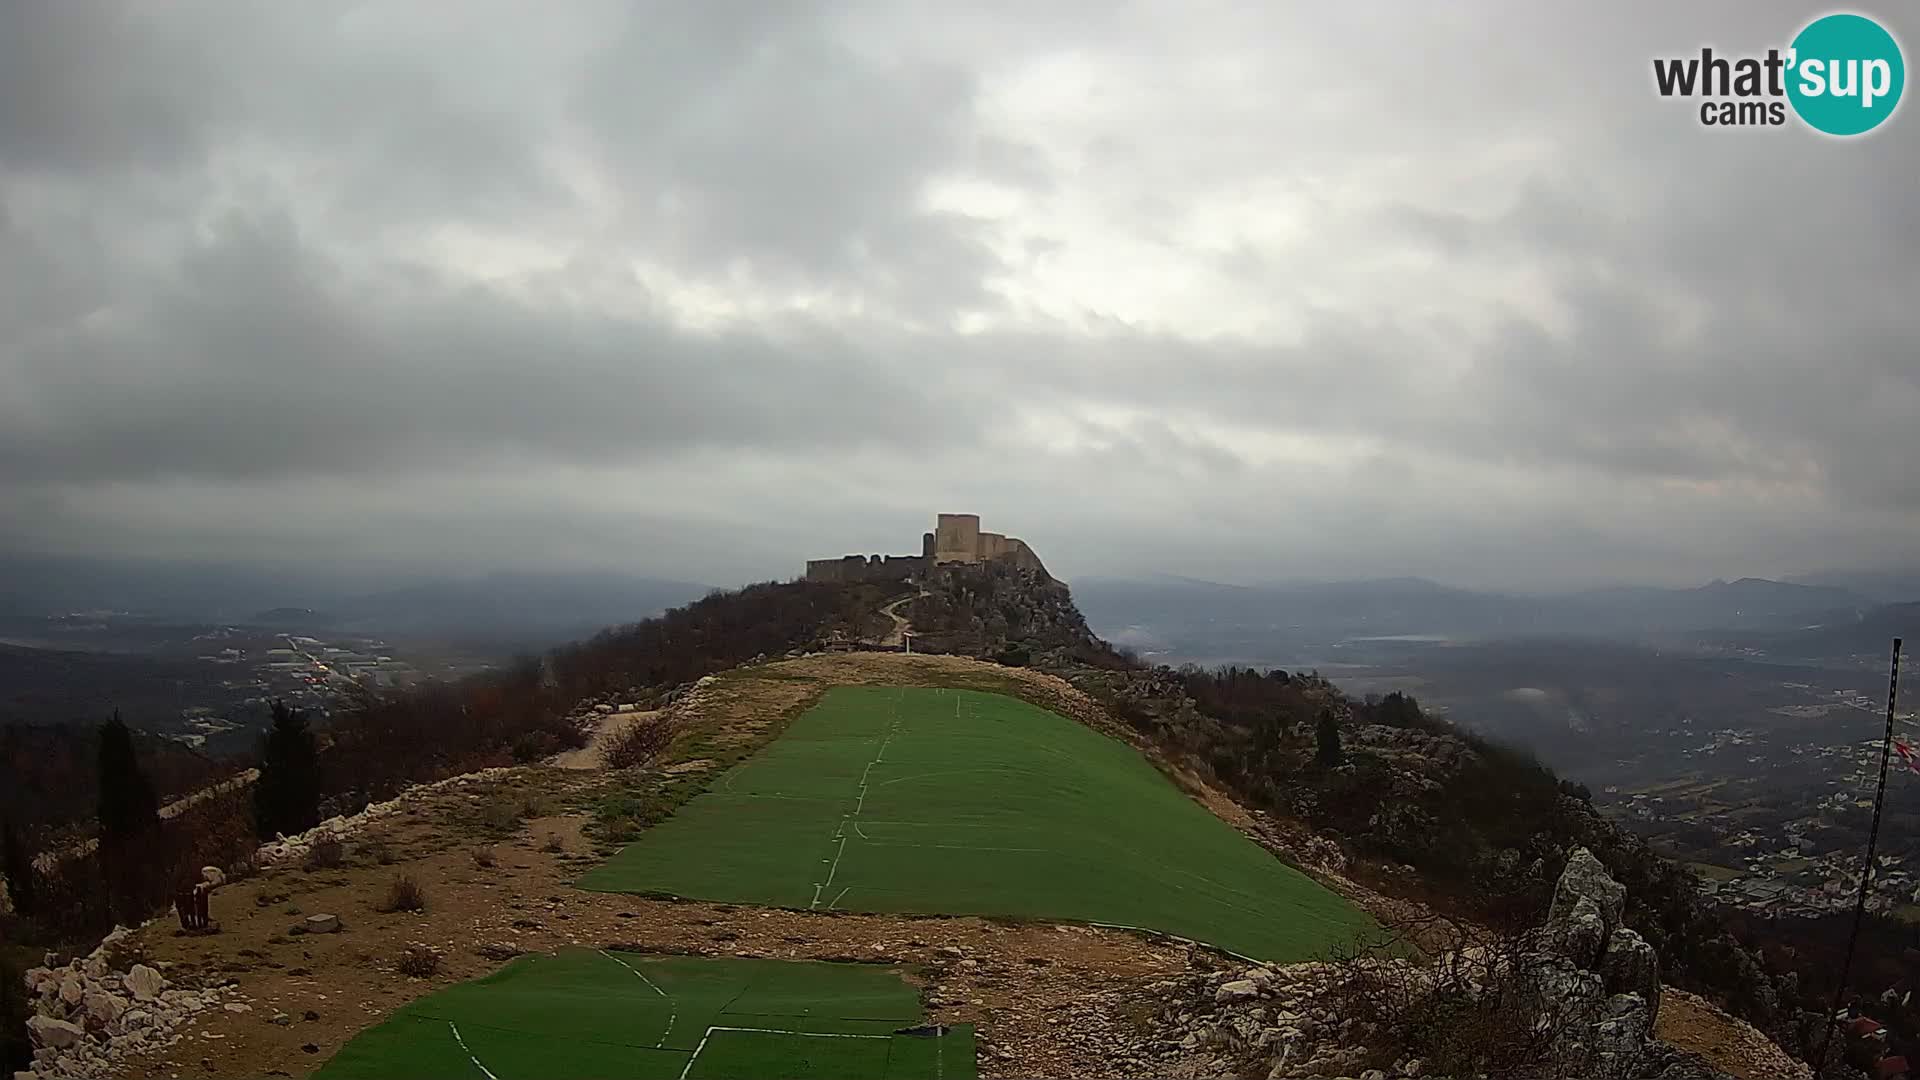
15, 653, 1791, 1080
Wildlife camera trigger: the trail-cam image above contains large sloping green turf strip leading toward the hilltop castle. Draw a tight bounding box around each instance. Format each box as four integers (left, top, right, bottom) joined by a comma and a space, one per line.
580, 686, 1373, 961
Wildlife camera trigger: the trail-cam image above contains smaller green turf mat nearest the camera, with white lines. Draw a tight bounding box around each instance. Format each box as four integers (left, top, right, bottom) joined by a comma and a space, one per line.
315, 949, 973, 1080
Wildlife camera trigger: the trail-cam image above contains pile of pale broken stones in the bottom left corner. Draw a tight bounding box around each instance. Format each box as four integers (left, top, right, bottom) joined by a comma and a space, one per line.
13, 914, 246, 1080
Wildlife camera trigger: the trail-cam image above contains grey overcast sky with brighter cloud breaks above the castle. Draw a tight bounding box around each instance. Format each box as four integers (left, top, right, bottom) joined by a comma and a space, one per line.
0, 0, 1920, 586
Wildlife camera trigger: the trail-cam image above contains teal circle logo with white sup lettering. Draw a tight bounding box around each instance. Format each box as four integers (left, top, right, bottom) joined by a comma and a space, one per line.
1788, 15, 1907, 135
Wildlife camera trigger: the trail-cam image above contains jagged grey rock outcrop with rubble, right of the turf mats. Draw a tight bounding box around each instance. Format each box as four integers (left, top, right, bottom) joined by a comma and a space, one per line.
1142, 849, 1758, 1080
